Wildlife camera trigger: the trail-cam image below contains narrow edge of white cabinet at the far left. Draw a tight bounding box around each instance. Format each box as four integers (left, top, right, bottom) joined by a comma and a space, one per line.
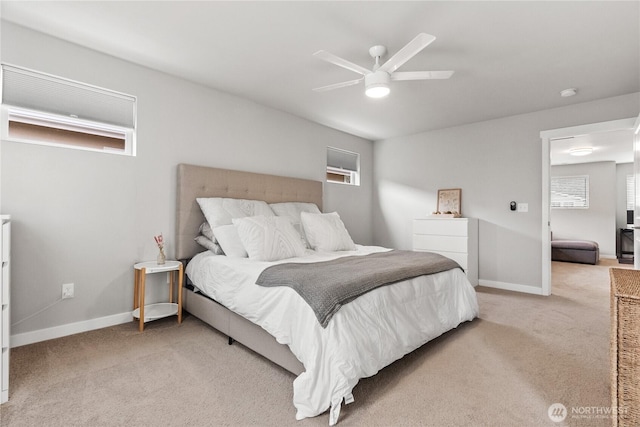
0, 215, 11, 403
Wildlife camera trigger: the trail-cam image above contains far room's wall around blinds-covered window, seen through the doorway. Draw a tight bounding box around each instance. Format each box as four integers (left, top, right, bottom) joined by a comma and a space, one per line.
550, 162, 617, 258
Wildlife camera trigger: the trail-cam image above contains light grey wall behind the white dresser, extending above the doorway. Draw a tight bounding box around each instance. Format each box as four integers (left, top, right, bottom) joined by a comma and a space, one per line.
373, 93, 640, 293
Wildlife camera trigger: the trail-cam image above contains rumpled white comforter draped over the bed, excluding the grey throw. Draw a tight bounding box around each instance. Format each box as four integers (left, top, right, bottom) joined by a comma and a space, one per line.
187, 245, 478, 425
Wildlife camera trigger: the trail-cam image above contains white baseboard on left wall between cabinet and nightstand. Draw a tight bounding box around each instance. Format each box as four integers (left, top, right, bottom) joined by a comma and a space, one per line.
9, 311, 133, 348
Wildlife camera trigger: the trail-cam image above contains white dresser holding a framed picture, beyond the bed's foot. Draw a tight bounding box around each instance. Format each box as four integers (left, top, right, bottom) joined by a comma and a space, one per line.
413, 218, 478, 286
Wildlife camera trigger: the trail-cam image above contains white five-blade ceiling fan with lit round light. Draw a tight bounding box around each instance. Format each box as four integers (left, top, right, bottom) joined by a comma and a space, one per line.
313, 33, 453, 98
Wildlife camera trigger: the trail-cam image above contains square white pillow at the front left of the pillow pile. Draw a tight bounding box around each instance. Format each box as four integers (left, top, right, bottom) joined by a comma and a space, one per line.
233, 216, 305, 261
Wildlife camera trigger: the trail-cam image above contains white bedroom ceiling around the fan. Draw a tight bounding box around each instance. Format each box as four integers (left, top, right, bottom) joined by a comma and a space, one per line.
0, 0, 640, 140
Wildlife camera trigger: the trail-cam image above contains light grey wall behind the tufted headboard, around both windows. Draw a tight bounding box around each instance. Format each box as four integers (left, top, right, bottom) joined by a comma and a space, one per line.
0, 22, 373, 345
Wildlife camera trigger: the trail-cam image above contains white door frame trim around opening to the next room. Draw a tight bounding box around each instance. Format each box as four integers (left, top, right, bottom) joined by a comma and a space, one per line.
540, 117, 636, 295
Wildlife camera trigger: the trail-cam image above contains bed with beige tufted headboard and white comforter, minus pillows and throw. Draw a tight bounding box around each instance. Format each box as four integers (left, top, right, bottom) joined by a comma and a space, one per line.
175, 164, 478, 425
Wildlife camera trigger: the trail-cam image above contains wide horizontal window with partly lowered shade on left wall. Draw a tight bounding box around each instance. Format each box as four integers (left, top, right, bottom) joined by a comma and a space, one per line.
1, 64, 136, 156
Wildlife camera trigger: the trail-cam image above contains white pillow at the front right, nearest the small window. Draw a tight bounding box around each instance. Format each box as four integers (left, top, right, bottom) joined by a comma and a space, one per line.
300, 212, 356, 252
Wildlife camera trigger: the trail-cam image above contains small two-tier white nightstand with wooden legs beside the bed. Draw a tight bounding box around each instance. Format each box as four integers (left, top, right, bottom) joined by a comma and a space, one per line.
131, 261, 183, 332
